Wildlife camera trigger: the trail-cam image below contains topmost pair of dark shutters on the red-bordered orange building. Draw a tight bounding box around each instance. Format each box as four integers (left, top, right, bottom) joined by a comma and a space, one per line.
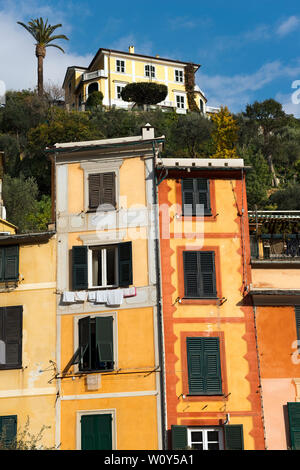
181, 178, 211, 215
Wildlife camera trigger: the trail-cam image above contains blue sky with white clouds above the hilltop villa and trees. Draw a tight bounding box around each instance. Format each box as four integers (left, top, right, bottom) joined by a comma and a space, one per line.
0, 0, 300, 117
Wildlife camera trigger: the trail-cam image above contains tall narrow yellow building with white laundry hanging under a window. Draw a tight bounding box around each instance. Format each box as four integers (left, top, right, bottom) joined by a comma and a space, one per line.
50, 126, 163, 450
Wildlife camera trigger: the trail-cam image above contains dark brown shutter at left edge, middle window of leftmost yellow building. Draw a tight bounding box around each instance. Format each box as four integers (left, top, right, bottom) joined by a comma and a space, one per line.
0, 306, 23, 369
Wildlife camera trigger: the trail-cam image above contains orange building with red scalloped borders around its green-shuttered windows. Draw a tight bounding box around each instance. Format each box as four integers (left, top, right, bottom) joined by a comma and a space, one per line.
157, 158, 264, 450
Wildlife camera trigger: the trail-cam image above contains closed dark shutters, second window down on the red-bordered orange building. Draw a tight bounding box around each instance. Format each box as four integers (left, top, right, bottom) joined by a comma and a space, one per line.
183, 251, 217, 298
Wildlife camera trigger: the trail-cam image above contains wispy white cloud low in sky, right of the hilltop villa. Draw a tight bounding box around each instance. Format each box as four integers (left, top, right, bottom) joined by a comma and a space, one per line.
197, 61, 300, 112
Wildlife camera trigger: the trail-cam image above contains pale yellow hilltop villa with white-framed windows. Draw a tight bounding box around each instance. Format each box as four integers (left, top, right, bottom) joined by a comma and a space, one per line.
63, 46, 209, 114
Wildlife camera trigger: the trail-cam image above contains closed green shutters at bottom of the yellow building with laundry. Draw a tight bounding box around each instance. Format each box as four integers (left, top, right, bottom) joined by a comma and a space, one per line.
81, 414, 112, 450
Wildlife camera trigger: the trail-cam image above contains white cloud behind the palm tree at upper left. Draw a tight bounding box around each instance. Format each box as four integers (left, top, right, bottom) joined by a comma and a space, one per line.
0, 1, 93, 90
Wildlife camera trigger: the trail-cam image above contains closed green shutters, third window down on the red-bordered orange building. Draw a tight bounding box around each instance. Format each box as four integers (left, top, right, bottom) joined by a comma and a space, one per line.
186, 337, 222, 395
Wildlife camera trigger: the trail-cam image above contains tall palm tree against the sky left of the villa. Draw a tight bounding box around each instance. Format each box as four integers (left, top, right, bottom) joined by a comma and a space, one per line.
17, 18, 69, 96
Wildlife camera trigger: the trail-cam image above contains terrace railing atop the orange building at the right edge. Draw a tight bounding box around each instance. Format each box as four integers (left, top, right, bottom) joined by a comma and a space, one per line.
250, 234, 300, 261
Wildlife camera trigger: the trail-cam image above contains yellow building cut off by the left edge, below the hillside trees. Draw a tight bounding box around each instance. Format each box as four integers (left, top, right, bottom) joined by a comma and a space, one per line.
0, 230, 56, 448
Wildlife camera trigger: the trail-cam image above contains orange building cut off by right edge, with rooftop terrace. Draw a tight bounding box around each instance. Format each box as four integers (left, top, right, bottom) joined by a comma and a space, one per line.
249, 211, 300, 450
